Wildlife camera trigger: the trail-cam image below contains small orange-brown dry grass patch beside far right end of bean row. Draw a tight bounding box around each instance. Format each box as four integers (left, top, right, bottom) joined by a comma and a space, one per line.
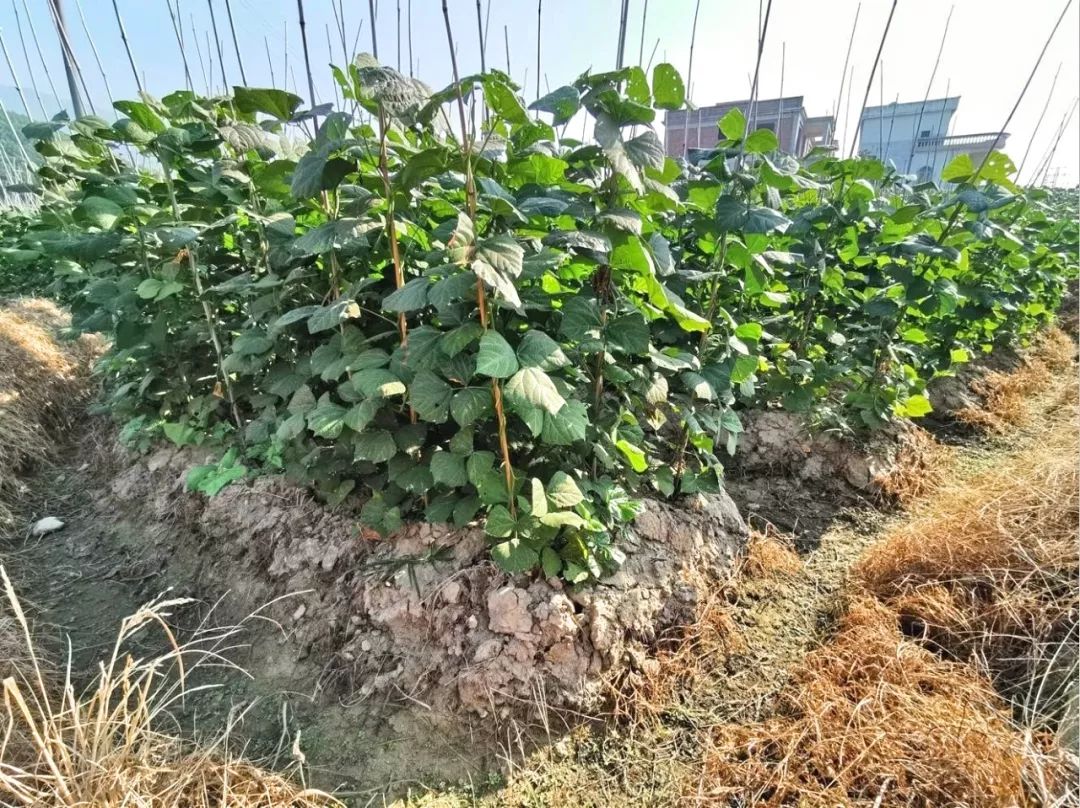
956, 328, 1076, 433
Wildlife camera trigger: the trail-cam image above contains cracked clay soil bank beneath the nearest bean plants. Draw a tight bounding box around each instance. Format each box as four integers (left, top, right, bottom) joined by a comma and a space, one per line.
106, 449, 747, 715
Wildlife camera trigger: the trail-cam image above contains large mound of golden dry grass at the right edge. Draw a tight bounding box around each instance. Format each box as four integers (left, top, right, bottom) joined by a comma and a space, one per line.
854, 385, 1080, 723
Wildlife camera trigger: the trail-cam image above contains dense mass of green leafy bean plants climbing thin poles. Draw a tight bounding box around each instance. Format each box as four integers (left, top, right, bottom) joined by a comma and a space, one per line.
4, 56, 1077, 584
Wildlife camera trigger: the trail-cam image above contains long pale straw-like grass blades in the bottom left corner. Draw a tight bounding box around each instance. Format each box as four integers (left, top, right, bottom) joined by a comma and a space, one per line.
0, 566, 339, 808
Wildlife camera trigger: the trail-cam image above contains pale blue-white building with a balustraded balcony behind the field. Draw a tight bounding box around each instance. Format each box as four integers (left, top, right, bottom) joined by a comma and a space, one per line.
859, 95, 1009, 183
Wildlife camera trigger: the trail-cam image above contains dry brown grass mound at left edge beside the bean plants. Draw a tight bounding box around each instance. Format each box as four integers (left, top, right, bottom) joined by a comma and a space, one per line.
0, 298, 103, 526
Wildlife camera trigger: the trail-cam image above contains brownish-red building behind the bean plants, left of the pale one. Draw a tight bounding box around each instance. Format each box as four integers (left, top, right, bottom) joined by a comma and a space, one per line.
664, 95, 834, 157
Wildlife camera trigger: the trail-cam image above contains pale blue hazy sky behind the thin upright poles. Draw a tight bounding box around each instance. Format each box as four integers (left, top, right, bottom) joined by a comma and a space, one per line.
0, 0, 1080, 184
